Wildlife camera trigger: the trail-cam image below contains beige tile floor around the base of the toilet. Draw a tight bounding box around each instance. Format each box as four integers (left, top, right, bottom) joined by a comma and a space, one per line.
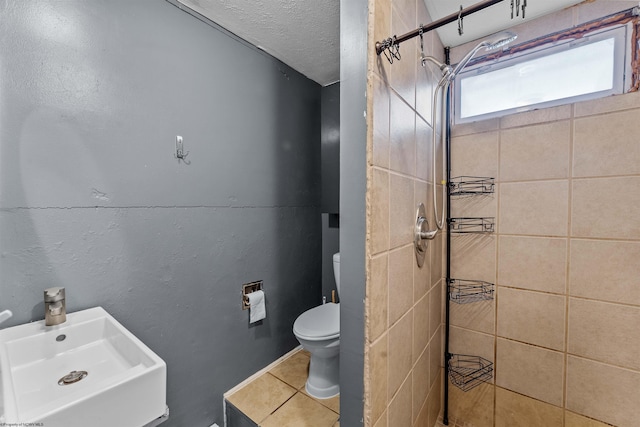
227, 350, 340, 427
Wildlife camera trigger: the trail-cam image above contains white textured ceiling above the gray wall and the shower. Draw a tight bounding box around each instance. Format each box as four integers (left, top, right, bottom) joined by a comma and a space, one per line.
178, 0, 582, 86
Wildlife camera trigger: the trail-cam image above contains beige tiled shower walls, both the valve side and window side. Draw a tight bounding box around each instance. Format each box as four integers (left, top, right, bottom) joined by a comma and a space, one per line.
365, 0, 640, 427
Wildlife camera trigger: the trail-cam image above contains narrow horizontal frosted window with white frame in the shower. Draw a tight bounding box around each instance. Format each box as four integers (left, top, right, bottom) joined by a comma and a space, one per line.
455, 26, 627, 123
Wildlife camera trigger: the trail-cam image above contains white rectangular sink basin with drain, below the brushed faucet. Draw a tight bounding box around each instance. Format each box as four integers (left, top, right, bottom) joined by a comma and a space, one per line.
0, 307, 167, 427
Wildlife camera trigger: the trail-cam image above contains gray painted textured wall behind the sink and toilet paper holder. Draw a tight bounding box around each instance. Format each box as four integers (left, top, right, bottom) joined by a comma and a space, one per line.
0, 0, 321, 427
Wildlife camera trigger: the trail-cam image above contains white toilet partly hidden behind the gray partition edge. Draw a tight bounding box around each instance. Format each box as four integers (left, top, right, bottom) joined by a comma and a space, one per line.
293, 252, 340, 399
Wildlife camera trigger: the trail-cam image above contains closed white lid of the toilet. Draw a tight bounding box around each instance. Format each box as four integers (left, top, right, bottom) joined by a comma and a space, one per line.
293, 302, 340, 341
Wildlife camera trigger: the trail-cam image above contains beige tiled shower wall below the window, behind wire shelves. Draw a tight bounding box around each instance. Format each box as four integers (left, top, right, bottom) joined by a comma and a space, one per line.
450, 93, 640, 426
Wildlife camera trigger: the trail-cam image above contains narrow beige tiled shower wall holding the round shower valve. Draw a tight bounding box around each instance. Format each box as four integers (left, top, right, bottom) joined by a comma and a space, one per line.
365, 0, 443, 426
